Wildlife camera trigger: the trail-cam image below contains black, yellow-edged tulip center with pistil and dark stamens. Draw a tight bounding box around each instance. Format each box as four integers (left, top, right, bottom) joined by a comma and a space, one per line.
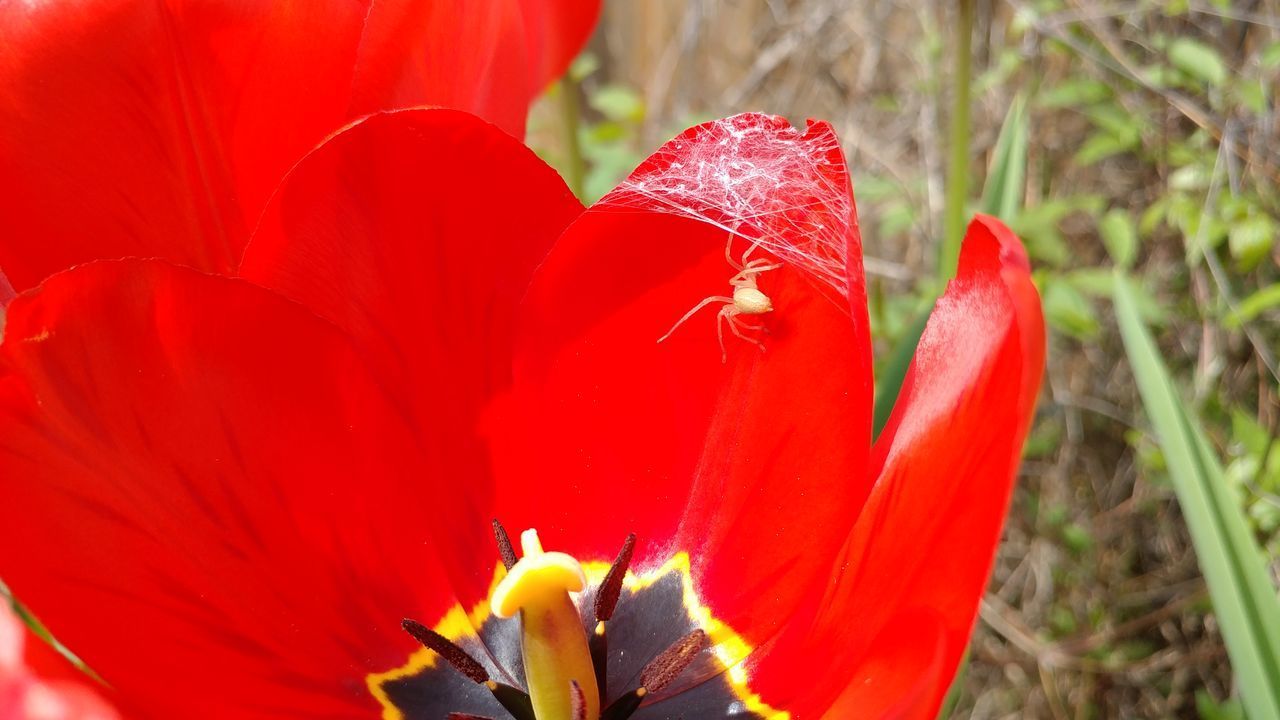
367, 520, 787, 720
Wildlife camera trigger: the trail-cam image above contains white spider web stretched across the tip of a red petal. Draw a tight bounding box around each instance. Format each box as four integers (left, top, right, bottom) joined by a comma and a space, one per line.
600, 113, 861, 305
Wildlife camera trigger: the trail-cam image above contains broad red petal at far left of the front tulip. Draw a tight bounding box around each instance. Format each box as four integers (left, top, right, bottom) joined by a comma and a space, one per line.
0, 261, 478, 719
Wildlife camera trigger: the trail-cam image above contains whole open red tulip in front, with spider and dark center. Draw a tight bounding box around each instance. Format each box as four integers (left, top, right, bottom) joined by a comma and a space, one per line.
0, 110, 1043, 720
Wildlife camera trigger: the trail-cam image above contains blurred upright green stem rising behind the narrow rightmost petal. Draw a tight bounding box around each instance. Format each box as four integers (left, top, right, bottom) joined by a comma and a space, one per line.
938, 0, 977, 282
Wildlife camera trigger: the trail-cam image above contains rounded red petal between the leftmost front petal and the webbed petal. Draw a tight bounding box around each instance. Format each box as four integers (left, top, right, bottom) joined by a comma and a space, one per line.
241, 110, 582, 591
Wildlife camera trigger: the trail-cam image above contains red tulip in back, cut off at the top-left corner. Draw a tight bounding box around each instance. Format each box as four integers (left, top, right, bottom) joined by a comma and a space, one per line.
0, 0, 595, 290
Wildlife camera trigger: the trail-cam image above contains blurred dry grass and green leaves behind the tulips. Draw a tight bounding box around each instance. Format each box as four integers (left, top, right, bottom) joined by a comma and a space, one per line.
530, 0, 1280, 720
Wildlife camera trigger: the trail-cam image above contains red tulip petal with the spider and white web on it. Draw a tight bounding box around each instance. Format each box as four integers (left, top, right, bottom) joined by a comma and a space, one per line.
495, 115, 870, 641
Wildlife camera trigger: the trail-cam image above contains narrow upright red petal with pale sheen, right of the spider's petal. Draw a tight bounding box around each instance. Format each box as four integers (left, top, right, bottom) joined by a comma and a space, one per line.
755, 217, 1044, 719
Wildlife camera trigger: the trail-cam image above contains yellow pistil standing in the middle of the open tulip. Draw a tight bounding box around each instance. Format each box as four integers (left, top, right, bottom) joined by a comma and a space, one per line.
490, 530, 600, 720
